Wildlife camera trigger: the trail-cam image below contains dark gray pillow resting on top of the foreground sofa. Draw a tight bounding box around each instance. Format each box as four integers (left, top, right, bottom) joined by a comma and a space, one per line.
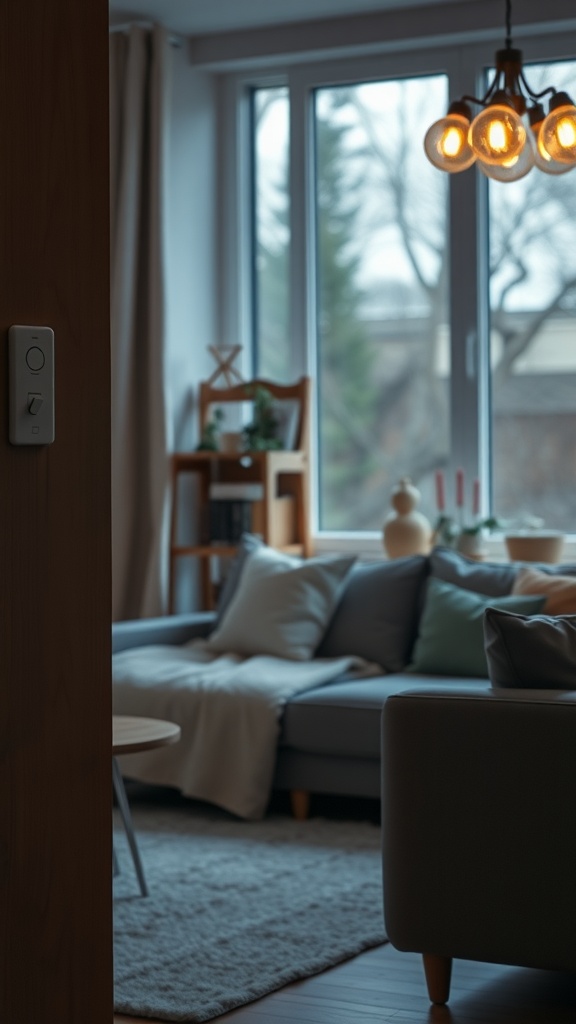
484, 608, 576, 690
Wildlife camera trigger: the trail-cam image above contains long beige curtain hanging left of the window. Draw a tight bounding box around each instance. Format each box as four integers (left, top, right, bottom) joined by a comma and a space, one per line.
110, 26, 171, 620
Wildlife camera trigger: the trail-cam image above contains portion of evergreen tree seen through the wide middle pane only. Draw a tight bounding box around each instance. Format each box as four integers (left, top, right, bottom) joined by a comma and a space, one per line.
317, 107, 376, 529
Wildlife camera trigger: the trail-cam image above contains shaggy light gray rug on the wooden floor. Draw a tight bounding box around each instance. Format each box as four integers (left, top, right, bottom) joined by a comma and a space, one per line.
114, 803, 385, 1022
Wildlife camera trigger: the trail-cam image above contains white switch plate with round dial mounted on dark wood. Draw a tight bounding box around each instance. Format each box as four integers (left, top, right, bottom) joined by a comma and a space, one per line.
8, 325, 54, 444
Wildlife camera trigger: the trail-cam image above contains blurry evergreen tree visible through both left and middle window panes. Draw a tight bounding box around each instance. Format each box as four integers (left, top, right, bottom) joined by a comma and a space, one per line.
256, 94, 376, 529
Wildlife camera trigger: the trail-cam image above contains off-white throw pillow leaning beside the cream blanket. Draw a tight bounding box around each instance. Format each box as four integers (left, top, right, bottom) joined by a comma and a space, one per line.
207, 546, 356, 662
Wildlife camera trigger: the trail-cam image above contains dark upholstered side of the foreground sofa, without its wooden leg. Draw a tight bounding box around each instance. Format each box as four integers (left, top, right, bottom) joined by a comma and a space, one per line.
382, 689, 576, 970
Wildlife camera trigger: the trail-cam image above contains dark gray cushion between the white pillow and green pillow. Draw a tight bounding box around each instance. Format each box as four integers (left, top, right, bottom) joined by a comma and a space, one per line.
316, 555, 427, 672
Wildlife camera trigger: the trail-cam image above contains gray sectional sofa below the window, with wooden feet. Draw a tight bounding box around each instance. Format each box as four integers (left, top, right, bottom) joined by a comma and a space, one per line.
113, 548, 576, 816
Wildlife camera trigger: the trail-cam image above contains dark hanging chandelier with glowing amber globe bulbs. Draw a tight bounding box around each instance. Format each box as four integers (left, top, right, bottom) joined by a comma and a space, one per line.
424, 0, 576, 181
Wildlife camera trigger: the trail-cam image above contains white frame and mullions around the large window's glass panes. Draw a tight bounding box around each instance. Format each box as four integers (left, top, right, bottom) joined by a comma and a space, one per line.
218, 27, 576, 556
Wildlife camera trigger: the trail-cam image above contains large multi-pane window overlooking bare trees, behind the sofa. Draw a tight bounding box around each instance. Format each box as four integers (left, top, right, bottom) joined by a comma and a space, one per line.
237, 39, 576, 532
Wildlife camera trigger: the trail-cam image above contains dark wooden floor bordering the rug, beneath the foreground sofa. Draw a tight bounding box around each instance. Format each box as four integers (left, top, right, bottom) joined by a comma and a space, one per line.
114, 943, 576, 1024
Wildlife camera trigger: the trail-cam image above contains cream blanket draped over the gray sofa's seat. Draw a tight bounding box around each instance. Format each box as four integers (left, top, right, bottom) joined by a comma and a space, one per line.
113, 640, 381, 818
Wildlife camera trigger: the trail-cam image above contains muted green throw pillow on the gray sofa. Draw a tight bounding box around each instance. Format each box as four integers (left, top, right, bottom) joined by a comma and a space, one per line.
406, 577, 546, 678
